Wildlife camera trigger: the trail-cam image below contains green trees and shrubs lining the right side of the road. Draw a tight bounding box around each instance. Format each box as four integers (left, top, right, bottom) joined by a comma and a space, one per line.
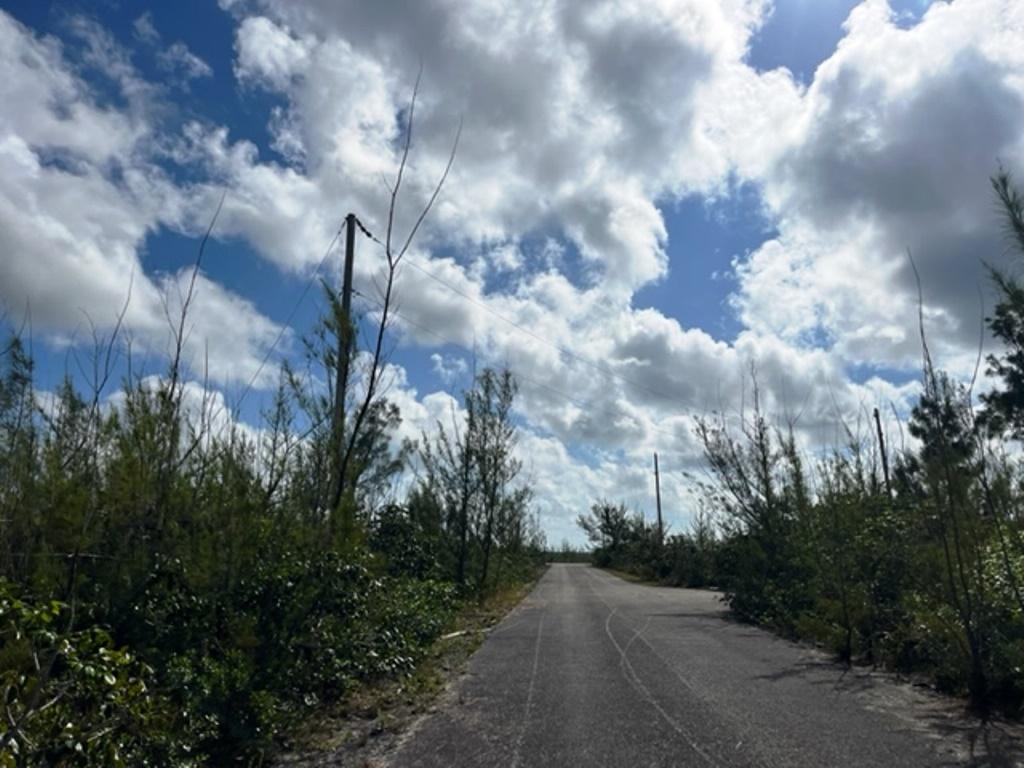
580, 174, 1024, 716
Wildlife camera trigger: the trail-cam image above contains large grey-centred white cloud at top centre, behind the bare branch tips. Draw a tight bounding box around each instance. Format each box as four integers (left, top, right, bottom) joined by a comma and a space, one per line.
209, 0, 791, 301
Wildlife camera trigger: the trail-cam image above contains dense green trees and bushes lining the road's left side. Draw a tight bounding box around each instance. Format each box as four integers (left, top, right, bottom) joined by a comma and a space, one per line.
0, 296, 541, 766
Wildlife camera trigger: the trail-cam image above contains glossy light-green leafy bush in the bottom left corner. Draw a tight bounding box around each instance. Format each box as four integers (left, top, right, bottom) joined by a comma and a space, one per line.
0, 581, 193, 766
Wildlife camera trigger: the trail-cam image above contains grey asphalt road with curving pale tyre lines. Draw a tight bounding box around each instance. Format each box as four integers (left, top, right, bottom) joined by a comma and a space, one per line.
391, 565, 1021, 768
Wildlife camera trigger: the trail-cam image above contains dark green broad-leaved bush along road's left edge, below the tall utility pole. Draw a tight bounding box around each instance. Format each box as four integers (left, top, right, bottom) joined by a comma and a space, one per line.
143, 551, 456, 760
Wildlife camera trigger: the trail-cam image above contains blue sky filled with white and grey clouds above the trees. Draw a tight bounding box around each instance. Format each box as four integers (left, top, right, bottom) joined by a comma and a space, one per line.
0, 0, 1024, 545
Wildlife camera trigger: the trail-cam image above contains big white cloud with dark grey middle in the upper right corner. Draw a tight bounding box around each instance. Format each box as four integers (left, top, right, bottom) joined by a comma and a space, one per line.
735, 0, 1024, 367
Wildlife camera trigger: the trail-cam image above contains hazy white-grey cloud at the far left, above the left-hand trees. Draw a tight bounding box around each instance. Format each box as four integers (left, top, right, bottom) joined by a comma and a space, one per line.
0, 13, 279, 382
